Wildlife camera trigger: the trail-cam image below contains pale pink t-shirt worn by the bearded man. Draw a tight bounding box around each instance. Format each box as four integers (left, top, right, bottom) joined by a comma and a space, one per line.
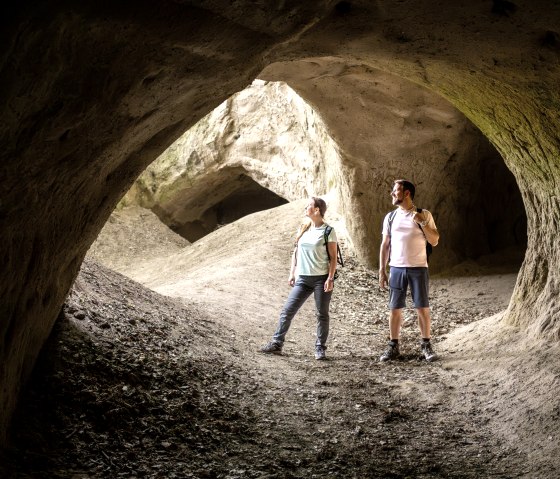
382, 208, 436, 268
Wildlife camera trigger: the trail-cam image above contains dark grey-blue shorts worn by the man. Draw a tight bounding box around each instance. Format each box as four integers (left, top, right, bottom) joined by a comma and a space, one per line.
389, 266, 430, 309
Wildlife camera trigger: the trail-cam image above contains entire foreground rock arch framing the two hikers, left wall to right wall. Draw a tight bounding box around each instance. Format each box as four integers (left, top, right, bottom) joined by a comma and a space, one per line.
0, 0, 560, 440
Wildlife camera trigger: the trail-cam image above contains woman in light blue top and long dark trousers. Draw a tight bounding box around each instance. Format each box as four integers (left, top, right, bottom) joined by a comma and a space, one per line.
261, 197, 337, 359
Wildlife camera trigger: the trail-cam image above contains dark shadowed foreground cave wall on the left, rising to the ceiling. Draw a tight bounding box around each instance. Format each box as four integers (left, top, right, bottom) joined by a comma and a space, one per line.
0, 1, 332, 442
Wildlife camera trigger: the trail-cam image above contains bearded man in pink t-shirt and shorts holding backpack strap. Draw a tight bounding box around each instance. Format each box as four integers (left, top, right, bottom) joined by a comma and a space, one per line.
379, 180, 439, 361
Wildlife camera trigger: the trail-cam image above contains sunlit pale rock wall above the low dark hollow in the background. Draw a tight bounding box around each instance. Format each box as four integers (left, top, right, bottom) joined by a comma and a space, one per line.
123, 80, 340, 237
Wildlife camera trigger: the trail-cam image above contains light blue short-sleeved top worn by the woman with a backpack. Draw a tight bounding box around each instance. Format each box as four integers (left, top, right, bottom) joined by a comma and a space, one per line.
296, 223, 337, 276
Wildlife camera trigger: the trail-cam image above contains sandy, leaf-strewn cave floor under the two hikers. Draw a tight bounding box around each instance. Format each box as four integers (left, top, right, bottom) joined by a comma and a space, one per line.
0, 205, 560, 479
